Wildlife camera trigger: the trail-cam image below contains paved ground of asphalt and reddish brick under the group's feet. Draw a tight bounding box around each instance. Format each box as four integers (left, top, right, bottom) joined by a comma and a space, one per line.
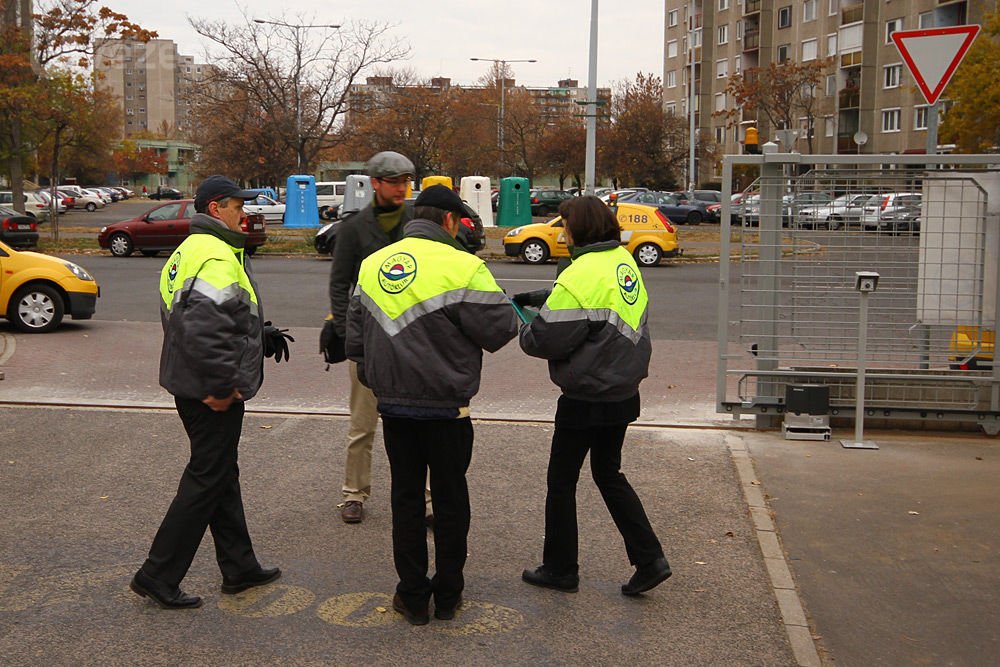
0, 321, 1000, 665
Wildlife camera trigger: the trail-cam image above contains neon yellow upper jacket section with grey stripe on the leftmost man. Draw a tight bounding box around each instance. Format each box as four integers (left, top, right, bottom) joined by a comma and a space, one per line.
160, 234, 258, 316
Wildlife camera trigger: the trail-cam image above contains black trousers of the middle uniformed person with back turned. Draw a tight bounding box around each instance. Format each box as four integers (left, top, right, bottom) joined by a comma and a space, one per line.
382, 415, 473, 610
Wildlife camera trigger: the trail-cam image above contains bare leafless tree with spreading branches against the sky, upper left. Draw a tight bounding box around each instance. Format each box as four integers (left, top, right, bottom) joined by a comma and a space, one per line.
191, 12, 409, 171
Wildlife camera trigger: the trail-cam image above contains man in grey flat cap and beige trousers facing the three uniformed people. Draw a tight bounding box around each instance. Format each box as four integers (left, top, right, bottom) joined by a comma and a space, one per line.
327, 151, 430, 523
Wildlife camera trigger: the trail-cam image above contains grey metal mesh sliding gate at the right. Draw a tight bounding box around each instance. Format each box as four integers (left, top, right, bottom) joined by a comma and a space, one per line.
717, 151, 1000, 434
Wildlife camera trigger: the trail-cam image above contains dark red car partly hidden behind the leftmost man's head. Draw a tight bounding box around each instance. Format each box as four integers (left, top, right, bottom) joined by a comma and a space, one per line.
97, 199, 267, 257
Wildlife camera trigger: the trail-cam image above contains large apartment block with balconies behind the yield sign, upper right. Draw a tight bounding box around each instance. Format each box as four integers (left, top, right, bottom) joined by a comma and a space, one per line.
663, 0, 996, 182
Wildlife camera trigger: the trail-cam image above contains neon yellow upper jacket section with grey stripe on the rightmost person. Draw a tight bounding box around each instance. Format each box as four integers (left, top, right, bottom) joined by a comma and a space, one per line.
541, 247, 649, 343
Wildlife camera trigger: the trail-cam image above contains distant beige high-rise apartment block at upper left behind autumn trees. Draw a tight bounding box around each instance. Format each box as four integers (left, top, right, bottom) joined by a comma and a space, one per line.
94, 39, 212, 137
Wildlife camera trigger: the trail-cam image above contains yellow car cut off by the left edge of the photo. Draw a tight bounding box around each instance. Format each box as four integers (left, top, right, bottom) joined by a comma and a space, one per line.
0, 242, 101, 333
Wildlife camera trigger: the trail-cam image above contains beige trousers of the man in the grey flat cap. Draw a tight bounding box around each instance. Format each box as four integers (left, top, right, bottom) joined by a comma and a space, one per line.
342, 361, 432, 514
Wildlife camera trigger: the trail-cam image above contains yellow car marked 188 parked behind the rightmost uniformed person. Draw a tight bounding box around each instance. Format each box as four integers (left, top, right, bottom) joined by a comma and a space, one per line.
503, 203, 681, 266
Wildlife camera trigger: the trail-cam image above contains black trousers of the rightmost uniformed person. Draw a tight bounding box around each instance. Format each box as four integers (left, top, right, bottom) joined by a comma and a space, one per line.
544, 424, 663, 575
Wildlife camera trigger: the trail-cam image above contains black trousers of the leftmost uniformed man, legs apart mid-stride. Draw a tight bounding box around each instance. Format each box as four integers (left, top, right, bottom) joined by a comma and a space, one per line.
142, 398, 260, 586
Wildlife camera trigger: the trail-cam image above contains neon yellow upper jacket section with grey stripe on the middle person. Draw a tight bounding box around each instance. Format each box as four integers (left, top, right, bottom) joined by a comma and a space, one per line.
355, 237, 507, 336
